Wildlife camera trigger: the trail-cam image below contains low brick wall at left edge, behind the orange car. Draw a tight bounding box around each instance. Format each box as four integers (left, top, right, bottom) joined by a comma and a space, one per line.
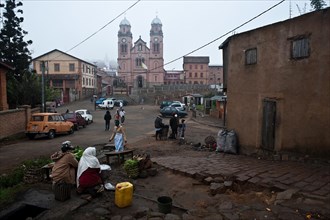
0, 105, 40, 140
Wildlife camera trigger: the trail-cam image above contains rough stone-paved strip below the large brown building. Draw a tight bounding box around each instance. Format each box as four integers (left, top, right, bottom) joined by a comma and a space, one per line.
153, 112, 330, 208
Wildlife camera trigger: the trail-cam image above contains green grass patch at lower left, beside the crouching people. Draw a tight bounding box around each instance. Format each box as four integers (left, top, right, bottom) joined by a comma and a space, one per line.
0, 157, 52, 209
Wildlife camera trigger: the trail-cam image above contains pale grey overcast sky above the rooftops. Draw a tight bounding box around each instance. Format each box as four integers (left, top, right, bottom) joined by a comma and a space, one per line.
19, 0, 330, 70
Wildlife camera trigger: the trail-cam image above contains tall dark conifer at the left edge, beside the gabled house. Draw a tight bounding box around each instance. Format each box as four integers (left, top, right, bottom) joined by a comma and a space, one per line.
0, 0, 36, 108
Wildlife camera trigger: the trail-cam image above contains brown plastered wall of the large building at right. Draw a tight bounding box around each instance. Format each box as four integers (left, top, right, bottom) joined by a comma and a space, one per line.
224, 8, 330, 154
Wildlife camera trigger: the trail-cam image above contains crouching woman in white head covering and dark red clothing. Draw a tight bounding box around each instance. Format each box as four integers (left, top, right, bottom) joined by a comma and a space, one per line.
77, 147, 103, 199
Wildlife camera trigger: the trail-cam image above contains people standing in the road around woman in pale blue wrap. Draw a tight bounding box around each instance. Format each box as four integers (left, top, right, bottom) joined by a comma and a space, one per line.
104, 107, 127, 152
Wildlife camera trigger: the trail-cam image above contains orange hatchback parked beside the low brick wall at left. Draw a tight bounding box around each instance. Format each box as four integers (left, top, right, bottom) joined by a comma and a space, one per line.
25, 113, 74, 139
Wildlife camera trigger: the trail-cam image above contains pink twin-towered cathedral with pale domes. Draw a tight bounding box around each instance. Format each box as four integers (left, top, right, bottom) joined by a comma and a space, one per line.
117, 17, 165, 91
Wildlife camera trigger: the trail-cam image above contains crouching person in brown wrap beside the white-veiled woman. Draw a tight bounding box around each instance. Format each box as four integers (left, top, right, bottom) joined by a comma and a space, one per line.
50, 141, 78, 184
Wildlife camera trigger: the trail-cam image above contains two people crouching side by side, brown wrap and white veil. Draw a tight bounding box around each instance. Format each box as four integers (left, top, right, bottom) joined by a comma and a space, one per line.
51, 141, 104, 201
